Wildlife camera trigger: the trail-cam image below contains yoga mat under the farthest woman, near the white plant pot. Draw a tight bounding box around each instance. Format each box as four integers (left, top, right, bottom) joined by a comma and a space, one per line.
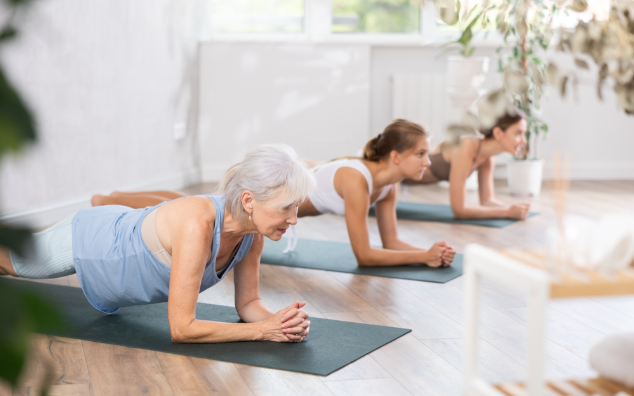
370, 201, 537, 228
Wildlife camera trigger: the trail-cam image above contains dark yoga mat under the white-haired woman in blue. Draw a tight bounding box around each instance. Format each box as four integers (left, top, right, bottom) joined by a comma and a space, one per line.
17, 280, 411, 375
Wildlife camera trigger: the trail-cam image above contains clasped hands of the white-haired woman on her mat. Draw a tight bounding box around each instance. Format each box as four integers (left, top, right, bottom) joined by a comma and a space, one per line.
262, 301, 310, 342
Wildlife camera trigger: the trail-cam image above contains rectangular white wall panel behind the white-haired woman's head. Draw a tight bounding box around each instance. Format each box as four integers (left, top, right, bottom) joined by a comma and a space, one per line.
199, 42, 370, 181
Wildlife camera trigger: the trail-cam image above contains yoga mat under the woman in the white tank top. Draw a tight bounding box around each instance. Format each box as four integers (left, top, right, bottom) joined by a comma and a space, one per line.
260, 239, 462, 283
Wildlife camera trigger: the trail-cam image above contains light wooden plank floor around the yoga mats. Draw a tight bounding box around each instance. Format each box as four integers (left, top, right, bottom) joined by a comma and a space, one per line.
0, 181, 634, 396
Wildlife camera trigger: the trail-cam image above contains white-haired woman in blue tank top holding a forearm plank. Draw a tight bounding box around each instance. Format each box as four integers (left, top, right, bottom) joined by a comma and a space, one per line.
0, 145, 315, 343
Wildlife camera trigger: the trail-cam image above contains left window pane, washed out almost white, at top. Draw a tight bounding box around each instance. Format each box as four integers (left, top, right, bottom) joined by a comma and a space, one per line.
211, 0, 304, 33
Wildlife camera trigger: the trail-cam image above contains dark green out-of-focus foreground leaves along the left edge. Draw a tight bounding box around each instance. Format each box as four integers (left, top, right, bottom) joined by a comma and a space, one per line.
0, 0, 63, 394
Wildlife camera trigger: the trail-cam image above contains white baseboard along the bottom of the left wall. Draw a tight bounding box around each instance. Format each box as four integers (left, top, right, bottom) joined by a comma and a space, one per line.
0, 169, 200, 229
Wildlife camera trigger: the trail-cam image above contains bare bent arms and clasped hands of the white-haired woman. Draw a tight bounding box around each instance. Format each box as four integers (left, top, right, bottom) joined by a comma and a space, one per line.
163, 197, 310, 343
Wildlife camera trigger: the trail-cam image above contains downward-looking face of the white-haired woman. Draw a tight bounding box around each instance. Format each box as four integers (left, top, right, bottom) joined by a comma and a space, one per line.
251, 192, 300, 241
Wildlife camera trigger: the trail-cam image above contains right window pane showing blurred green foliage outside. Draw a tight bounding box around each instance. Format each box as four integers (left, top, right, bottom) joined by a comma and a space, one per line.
332, 0, 421, 34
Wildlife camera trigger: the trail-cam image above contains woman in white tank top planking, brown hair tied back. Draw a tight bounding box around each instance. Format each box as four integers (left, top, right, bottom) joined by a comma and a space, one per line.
93, 120, 456, 267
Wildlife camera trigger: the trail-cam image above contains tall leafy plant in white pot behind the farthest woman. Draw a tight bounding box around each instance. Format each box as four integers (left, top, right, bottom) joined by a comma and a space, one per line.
446, 0, 558, 196
